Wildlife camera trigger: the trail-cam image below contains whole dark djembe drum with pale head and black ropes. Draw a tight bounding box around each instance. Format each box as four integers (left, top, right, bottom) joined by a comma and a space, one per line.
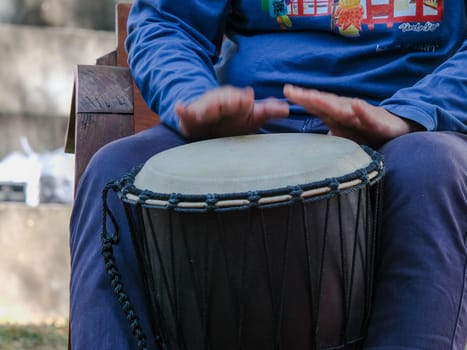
104, 134, 383, 350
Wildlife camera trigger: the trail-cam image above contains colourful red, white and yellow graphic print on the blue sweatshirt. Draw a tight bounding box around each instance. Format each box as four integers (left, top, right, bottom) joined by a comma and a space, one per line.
262, 0, 443, 36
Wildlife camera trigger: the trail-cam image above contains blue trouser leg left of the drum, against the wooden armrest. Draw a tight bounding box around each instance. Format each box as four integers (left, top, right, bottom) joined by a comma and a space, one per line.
70, 126, 185, 350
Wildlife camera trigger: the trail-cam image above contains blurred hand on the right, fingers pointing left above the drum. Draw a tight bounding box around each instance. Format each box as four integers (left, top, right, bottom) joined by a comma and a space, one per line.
284, 84, 421, 147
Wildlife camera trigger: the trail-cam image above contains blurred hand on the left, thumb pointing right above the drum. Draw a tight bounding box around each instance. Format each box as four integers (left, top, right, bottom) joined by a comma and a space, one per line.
175, 86, 289, 139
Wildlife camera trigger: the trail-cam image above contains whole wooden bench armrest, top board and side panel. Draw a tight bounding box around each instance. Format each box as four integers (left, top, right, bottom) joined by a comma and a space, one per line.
65, 65, 134, 191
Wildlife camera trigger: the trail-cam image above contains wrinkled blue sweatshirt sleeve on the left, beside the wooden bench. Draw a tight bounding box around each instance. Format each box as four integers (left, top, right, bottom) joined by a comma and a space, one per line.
126, 0, 229, 129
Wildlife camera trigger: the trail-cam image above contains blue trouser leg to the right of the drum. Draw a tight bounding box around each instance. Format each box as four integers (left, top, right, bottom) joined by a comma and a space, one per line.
367, 132, 467, 350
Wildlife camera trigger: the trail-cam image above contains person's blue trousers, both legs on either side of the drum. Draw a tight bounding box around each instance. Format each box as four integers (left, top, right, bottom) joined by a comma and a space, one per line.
70, 125, 467, 350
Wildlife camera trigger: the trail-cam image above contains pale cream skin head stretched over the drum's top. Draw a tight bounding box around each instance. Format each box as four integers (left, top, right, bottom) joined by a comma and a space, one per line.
134, 134, 372, 195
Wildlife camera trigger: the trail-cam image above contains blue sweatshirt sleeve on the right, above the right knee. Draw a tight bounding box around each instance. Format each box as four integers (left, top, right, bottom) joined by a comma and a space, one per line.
380, 39, 467, 133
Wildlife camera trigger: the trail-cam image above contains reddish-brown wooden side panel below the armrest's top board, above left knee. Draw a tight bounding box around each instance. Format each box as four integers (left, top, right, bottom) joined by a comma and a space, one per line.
75, 113, 133, 188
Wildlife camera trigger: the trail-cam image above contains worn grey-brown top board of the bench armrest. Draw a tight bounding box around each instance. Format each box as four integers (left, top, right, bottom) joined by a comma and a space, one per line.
75, 65, 133, 114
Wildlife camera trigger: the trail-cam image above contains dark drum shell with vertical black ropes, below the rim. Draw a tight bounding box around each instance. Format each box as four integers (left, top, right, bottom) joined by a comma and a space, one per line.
125, 183, 381, 350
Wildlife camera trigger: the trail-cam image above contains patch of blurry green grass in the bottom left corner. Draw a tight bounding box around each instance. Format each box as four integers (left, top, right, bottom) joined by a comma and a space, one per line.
0, 324, 68, 350
